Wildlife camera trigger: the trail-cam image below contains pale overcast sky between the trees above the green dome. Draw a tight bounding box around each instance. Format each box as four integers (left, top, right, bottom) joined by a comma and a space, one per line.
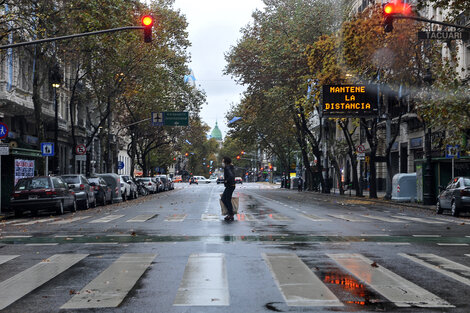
175, 0, 264, 137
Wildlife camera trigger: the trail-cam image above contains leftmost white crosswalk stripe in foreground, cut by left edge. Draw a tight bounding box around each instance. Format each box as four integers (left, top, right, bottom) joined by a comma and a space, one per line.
0, 254, 88, 310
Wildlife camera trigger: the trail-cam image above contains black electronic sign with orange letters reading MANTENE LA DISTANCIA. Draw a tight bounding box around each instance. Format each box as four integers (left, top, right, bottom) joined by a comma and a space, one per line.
322, 85, 378, 117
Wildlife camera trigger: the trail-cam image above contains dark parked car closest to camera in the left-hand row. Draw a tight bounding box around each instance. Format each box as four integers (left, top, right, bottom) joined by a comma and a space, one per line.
10, 176, 77, 217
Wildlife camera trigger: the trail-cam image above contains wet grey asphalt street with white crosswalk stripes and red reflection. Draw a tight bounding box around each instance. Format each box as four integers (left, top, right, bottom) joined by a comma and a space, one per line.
0, 183, 470, 313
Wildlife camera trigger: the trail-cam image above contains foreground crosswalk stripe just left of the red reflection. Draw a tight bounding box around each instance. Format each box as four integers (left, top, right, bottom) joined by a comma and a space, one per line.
263, 253, 343, 306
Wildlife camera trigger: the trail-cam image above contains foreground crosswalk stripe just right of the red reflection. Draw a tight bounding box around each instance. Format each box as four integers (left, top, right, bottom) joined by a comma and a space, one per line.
328, 253, 454, 308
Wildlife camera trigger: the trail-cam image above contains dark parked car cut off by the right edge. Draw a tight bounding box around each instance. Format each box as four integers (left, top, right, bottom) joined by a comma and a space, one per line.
436, 177, 470, 216
